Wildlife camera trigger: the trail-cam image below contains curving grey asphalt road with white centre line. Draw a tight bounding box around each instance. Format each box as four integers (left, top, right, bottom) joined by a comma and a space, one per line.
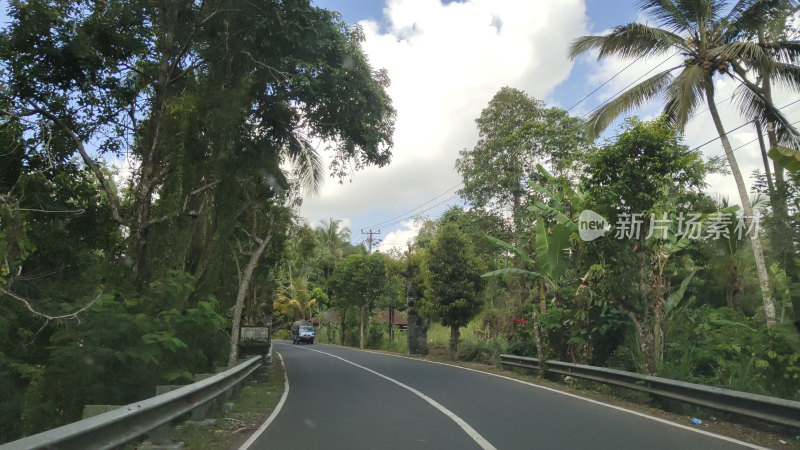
242, 342, 756, 450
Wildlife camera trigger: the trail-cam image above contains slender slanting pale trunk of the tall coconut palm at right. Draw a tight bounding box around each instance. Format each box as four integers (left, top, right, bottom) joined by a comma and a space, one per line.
706, 83, 775, 326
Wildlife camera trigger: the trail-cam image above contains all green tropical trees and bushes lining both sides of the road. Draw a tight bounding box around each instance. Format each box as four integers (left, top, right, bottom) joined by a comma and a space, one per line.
0, 0, 800, 441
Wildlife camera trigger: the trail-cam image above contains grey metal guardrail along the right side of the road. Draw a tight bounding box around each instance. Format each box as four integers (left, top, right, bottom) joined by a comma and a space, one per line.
500, 355, 800, 429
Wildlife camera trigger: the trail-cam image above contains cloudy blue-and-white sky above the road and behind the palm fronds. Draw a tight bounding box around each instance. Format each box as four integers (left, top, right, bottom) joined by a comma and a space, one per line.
302, 0, 800, 250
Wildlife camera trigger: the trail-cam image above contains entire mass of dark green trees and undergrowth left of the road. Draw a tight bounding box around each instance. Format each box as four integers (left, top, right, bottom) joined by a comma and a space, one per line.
0, 0, 395, 441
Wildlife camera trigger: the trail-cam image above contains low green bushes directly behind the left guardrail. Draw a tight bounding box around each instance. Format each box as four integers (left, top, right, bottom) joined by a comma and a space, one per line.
0, 274, 229, 437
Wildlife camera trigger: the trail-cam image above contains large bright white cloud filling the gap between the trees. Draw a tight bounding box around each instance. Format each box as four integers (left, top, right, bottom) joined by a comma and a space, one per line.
301, 0, 587, 227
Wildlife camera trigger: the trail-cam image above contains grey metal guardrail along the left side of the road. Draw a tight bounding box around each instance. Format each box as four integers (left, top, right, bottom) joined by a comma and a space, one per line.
0, 352, 272, 450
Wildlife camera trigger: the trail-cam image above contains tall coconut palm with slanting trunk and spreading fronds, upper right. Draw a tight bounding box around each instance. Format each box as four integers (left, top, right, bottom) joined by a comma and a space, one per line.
570, 0, 800, 325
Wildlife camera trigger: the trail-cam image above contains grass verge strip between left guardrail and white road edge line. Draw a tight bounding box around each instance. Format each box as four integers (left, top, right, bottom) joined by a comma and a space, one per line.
170, 358, 284, 450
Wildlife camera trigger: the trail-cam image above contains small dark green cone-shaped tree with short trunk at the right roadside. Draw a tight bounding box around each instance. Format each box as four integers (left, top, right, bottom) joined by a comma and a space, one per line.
420, 223, 483, 359
